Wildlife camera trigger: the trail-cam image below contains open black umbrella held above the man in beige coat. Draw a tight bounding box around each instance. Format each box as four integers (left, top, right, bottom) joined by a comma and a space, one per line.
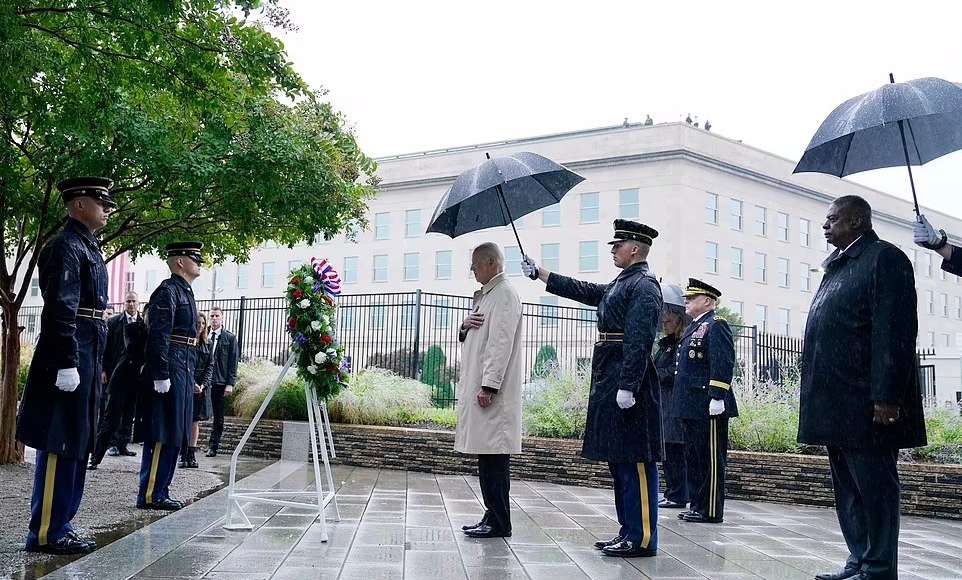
428, 151, 585, 255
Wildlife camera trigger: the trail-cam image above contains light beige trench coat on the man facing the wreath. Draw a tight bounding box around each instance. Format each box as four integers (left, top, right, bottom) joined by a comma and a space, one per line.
454, 272, 522, 454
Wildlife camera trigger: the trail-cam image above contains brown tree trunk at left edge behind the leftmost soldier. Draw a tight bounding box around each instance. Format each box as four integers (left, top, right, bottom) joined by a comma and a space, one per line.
0, 302, 23, 465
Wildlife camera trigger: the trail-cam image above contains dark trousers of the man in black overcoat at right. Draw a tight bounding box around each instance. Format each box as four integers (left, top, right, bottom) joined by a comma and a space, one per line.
828, 447, 900, 580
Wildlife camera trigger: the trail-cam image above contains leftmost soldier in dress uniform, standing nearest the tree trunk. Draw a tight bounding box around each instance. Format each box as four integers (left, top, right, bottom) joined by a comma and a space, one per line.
17, 177, 116, 554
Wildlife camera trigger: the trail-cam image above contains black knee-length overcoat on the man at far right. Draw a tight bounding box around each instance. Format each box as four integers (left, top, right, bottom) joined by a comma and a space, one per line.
798, 230, 926, 450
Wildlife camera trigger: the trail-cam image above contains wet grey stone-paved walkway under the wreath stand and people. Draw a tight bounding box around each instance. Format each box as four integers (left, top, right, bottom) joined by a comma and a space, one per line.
37, 462, 962, 580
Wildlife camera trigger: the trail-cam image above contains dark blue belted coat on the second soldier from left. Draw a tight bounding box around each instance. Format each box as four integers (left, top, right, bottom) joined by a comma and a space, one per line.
134, 275, 197, 448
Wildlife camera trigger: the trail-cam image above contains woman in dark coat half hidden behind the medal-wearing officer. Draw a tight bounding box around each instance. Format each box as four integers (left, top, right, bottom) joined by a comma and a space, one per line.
655, 285, 691, 508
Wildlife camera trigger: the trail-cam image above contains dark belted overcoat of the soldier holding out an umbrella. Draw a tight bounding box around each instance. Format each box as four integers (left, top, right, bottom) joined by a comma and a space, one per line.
547, 262, 663, 463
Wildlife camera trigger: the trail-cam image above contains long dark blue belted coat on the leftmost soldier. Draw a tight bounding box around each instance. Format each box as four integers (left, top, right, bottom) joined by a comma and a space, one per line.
17, 219, 107, 460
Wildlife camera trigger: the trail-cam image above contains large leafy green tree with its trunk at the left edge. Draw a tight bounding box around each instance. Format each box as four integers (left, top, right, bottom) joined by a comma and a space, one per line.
0, 0, 376, 463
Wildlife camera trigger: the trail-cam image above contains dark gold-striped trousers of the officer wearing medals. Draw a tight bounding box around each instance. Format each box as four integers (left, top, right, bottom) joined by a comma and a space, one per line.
684, 416, 728, 518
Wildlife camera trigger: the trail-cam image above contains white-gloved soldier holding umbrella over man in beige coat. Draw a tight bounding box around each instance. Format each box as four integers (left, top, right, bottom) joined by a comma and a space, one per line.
522, 220, 662, 557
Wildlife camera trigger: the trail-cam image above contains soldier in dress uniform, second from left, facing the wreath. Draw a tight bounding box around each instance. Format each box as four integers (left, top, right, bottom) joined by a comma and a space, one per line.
134, 242, 204, 511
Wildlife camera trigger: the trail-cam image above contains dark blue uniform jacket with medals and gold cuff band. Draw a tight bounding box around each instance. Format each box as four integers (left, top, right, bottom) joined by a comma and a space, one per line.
672, 310, 738, 419
